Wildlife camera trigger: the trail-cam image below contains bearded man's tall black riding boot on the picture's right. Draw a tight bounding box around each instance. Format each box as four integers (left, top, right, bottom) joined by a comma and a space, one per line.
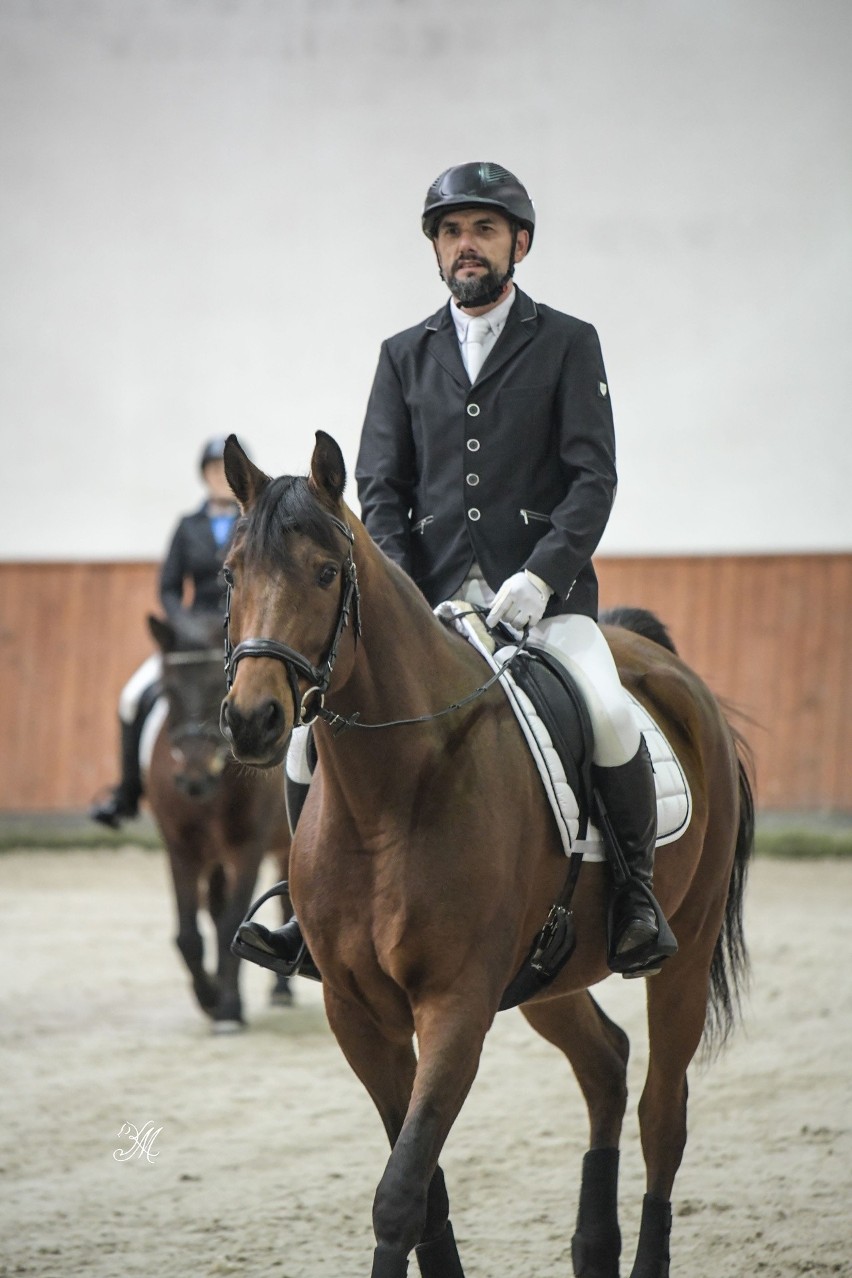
594, 737, 677, 976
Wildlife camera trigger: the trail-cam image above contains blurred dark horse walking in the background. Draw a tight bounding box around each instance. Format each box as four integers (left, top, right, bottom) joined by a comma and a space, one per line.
146, 613, 291, 1031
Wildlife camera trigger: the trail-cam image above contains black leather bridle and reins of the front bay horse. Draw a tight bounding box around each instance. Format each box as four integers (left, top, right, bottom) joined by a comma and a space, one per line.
225, 515, 529, 736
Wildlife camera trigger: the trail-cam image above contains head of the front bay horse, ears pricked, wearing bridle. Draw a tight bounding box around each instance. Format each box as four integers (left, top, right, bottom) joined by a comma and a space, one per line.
221, 431, 358, 767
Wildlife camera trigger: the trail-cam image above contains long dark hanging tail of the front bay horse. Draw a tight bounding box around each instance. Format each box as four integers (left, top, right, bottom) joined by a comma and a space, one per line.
703, 728, 755, 1058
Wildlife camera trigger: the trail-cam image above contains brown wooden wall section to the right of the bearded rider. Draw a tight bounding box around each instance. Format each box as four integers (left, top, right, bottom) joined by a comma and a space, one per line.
597, 555, 852, 812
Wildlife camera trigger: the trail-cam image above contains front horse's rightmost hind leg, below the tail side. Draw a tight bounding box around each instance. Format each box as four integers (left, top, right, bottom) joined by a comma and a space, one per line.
631, 955, 709, 1278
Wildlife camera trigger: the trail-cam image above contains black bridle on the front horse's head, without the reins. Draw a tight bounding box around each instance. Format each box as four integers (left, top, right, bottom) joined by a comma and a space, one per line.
225, 515, 361, 725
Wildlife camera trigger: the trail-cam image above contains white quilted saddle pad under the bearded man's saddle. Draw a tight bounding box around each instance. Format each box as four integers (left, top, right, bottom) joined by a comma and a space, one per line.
434, 602, 692, 861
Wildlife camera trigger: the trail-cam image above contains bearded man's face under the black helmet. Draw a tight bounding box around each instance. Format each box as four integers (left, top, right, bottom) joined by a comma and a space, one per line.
434, 208, 530, 308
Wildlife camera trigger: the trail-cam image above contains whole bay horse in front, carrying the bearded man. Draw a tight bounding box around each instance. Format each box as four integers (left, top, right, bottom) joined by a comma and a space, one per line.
222, 431, 754, 1278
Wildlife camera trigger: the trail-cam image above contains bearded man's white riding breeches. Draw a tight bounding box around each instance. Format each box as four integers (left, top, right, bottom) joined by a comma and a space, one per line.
459, 565, 641, 768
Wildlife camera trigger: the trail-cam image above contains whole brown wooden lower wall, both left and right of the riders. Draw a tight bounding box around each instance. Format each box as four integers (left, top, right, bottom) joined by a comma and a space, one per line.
0, 555, 852, 812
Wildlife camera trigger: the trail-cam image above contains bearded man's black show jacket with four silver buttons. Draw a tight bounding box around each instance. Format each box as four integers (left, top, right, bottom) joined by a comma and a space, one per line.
355, 289, 616, 617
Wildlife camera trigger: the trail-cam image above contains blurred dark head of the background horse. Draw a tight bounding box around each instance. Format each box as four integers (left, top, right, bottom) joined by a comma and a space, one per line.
148, 613, 230, 799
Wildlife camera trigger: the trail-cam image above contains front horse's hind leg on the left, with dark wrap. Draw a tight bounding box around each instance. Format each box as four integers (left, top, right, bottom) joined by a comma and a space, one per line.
521, 990, 630, 1278
